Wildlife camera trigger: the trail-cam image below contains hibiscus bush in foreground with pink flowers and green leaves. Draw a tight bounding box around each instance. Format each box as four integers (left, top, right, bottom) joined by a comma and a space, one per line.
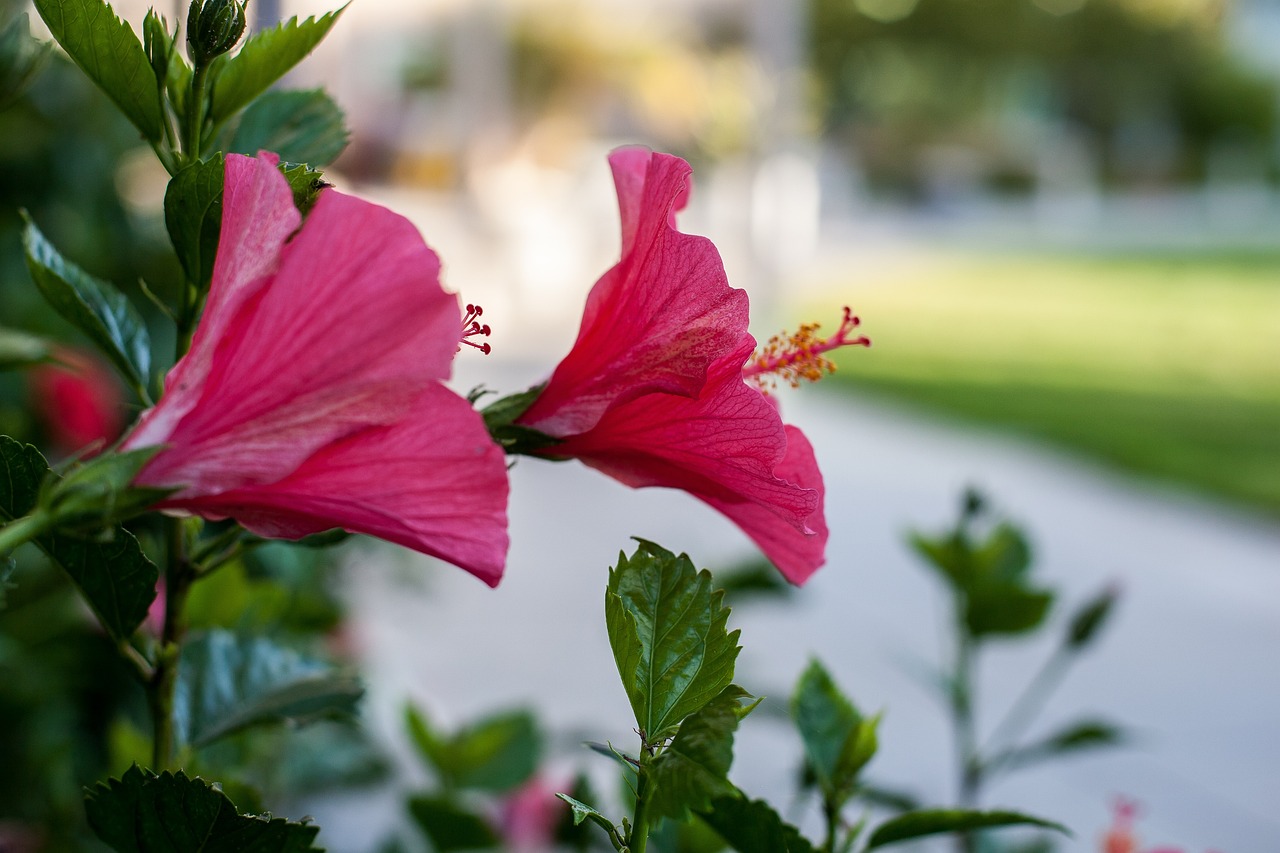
0, 0, 1100, 853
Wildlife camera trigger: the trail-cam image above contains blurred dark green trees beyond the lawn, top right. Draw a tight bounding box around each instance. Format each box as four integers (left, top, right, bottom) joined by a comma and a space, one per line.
810, 0, 1276, 190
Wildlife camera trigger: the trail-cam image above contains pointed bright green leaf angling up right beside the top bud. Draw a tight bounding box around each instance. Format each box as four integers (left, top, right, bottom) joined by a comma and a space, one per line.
210, 6, 346, 124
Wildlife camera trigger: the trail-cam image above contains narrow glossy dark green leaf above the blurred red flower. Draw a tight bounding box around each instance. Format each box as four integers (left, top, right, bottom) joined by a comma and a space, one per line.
22, 218, 151, 397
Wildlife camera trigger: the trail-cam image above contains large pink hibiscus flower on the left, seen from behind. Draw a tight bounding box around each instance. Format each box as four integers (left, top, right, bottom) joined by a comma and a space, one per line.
124, 154, 508, 585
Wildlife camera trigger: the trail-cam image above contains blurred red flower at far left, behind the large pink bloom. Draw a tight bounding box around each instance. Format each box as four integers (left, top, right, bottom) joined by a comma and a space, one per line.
28, 348, 124, 455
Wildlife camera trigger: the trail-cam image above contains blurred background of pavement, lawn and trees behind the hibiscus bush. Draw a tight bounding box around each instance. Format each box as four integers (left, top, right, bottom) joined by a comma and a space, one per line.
0, 0, 1280, 853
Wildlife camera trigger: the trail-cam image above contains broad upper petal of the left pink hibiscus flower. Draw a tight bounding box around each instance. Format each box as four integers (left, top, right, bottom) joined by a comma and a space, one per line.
128, 156, 461, 494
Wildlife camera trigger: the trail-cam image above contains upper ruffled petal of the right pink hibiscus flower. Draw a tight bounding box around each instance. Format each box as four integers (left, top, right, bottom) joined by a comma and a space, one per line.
521, 149, 748, 437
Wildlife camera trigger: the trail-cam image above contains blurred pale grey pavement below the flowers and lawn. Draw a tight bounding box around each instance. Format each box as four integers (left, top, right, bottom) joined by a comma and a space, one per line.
296, 369, 1280, 853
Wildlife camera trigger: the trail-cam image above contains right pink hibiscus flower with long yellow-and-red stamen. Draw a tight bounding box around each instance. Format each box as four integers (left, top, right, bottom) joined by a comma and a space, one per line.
517, 149, 864, 584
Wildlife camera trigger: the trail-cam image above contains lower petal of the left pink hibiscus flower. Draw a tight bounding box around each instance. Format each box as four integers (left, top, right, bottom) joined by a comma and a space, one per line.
164, 383, 508, 587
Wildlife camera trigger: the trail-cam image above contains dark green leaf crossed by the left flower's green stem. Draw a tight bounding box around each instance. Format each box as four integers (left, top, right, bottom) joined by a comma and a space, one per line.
0, 435, 160, 640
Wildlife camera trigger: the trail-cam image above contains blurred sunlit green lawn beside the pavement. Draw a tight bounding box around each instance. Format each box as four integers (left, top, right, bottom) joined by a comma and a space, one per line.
822, 249, 1280, 516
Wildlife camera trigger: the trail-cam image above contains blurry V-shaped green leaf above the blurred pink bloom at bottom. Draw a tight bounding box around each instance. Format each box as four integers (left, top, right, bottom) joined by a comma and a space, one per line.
404, 706, 541, 792
